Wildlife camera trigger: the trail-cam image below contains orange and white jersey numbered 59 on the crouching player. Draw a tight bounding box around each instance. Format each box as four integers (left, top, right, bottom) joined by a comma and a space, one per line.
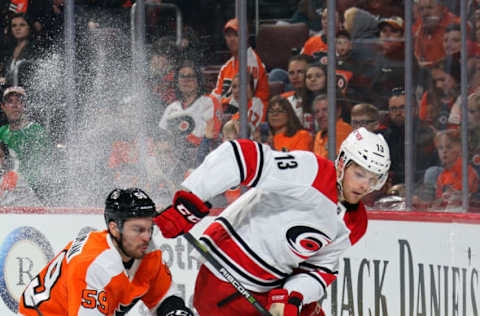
19, 231, 172, 316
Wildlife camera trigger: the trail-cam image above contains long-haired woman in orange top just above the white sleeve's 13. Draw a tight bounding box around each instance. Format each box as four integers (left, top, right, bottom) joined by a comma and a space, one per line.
267, 96, 313, 151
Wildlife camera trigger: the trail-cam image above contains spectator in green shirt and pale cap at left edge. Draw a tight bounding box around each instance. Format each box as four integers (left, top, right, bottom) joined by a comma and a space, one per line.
0, 87, 55, 199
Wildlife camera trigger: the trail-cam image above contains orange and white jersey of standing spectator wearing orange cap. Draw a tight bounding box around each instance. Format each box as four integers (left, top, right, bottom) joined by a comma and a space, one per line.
212, 47, 270, 104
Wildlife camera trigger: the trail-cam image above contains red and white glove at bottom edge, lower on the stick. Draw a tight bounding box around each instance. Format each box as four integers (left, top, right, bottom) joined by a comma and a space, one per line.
267, 289, 303, 316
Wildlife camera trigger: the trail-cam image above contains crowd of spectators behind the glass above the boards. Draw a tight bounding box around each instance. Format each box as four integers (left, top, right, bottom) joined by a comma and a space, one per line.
0, 0, 480, 211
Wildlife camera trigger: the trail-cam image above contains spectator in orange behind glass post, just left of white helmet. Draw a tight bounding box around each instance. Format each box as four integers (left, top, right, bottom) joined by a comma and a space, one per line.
313, 94, 353, 158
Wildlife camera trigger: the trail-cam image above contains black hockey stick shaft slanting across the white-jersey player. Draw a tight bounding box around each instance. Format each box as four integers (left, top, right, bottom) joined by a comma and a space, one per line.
183, 232, 272, 316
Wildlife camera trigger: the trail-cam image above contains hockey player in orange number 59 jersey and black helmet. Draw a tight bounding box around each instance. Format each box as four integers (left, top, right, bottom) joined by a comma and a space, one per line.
19, 188, 193, 316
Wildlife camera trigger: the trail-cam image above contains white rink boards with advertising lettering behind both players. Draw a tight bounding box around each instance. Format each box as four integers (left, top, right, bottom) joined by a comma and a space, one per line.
0, 210, 480, 316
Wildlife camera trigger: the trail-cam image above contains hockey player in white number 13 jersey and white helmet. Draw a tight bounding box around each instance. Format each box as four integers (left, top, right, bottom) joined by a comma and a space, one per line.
154, 128, 390, 316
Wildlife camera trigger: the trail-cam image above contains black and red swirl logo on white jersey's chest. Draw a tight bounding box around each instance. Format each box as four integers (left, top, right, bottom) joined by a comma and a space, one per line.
286, 226, 331, 259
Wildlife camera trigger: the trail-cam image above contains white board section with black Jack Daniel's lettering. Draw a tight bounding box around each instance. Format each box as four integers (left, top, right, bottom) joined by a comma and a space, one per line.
322, 215, 480, 316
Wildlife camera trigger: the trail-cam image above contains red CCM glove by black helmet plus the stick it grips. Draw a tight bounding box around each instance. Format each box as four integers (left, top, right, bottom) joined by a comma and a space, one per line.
154, 191, 272, 316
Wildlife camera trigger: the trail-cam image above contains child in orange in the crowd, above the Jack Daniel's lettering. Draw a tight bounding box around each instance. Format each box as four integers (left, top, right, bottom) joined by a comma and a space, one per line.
426, 130, 478, 208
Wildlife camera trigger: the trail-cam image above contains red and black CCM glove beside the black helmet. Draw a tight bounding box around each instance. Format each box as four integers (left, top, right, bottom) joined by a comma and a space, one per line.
153, 191, 210, 238
